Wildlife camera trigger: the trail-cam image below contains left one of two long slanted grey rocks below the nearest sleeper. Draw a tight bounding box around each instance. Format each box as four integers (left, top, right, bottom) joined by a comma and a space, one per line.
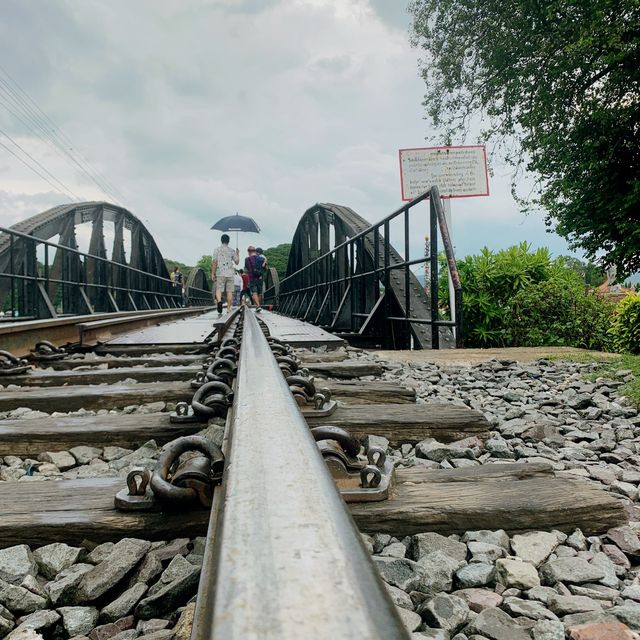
77, 538, 151, 602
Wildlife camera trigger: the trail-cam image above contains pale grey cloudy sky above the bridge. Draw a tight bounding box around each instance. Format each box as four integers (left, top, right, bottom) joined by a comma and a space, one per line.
0, 0, 580, 264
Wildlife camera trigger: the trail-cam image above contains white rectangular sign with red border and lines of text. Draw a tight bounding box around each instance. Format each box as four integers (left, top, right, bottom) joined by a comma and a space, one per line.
398, 145, 489, 200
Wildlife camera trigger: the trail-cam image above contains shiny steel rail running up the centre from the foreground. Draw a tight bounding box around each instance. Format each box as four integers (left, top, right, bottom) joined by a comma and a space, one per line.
191, 310, 410, 640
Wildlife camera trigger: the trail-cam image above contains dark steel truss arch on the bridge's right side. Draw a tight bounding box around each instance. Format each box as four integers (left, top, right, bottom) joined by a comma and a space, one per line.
276, 203, 451, 349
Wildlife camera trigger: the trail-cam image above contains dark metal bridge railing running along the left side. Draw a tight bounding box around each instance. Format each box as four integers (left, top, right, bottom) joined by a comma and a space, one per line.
0, 227, 211, 318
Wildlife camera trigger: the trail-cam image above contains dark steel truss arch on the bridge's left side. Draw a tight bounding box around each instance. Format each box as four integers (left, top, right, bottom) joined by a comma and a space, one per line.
0, 201, 182, 317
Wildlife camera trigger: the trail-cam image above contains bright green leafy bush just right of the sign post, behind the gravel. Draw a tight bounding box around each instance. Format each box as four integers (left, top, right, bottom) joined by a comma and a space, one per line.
458, 242, 613, 349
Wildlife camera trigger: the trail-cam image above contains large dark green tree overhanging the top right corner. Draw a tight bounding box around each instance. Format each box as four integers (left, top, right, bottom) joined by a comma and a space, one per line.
409, 0, 640, 275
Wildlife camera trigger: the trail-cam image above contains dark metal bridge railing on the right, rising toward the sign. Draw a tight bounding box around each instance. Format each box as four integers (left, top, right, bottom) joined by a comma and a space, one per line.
264, 186, 463, 349
